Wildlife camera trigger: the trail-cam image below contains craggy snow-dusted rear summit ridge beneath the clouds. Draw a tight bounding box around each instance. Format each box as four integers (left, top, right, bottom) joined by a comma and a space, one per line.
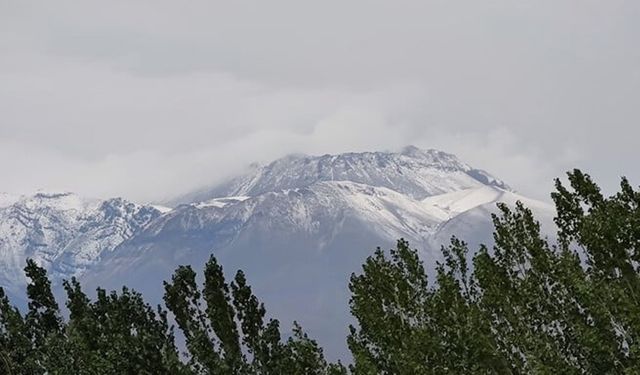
170, 146, 508, 205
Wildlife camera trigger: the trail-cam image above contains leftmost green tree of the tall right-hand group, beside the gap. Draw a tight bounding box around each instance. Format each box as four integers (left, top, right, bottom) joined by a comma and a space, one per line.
348, 240, 431, 374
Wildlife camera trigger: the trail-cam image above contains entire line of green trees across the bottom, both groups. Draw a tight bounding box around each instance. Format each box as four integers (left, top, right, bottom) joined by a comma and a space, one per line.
0, 170, 640, 375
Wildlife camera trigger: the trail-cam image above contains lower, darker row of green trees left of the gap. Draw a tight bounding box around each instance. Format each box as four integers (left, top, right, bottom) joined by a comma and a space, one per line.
0, 257, 346, 375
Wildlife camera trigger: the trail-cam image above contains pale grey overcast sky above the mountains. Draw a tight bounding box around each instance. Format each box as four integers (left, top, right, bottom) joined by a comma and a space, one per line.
0, 0, 640, 201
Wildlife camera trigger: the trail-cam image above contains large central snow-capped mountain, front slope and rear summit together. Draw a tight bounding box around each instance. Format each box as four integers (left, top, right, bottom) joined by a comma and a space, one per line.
80, 149, 552, 358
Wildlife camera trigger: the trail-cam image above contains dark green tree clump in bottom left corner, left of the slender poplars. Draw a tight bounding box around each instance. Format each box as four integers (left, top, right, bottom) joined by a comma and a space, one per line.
0, 260, 187, 375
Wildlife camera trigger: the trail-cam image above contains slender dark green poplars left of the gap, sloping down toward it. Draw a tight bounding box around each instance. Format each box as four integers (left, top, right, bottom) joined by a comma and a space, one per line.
164, 256, 346, 375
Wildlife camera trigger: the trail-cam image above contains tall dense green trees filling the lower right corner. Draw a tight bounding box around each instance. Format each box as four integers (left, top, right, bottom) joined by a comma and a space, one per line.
348, 170, 640, 374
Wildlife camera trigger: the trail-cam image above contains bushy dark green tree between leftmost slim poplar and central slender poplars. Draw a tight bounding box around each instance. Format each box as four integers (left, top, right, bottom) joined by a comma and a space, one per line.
64, 279, 186, 374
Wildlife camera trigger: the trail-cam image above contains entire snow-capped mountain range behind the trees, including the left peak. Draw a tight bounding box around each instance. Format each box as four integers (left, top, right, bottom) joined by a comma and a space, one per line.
0, 147, 554, 358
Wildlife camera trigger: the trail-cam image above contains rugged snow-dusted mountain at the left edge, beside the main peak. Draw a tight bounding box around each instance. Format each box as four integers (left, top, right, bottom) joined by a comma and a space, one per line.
0, 192, 160, 302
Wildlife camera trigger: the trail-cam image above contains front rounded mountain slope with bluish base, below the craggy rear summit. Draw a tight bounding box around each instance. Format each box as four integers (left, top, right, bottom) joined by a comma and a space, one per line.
83, 181, 450, 362
